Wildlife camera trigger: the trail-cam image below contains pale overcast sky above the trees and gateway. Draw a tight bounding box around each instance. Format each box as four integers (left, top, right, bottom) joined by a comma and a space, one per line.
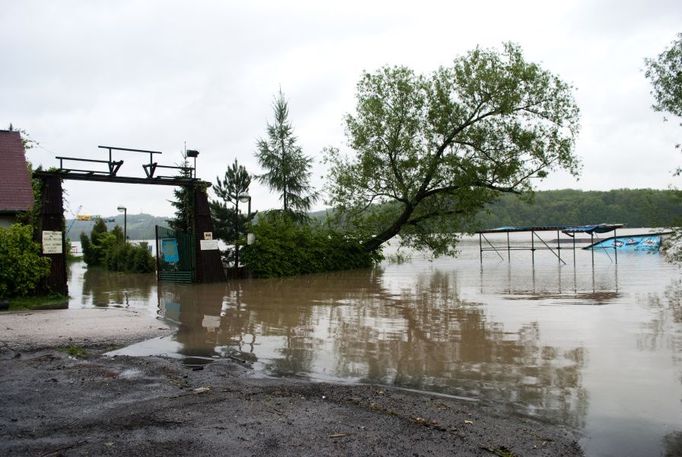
0, 0, 682, 216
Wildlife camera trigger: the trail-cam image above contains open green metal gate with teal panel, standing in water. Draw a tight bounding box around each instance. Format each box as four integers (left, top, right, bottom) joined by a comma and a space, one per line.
156, 225, 196, 283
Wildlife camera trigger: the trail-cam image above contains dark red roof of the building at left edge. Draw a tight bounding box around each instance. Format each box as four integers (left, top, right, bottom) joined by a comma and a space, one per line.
0, 130, 33, 213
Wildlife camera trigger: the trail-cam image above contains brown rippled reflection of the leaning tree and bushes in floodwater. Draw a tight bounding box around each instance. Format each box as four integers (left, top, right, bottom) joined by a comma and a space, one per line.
159, 270, 587, 426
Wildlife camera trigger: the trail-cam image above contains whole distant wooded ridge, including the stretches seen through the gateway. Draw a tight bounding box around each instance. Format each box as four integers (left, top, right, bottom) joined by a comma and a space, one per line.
66, 189, 682, 241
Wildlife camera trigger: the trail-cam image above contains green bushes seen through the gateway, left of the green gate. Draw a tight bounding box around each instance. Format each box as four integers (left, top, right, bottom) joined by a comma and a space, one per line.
81, 219, 156, 273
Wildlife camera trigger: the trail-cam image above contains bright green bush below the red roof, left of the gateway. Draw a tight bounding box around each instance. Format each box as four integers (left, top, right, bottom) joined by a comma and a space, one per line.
0, 224, 50, 297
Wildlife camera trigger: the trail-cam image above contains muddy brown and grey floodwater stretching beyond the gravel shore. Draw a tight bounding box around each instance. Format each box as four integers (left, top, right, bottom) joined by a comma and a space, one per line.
69, 235, 682, 456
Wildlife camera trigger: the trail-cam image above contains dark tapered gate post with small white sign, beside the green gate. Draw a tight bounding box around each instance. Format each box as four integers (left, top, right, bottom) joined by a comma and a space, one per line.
192, 183, 225, 282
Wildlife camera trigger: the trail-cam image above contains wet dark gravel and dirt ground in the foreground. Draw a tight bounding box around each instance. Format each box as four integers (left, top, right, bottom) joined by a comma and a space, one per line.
0, 308, 583, 457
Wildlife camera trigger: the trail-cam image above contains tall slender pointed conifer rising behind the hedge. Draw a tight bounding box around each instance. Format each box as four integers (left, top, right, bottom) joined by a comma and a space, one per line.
256, 91, 318, 218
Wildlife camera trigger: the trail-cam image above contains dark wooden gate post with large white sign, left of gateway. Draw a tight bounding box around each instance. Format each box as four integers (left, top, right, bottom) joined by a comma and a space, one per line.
36, 175, 69, 296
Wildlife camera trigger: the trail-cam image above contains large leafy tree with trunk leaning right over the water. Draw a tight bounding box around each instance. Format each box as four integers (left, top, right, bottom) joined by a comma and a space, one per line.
327, 44, 579, 255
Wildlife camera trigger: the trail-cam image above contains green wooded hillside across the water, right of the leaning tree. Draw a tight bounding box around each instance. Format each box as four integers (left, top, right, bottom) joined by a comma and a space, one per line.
467, 189, 682, 230
